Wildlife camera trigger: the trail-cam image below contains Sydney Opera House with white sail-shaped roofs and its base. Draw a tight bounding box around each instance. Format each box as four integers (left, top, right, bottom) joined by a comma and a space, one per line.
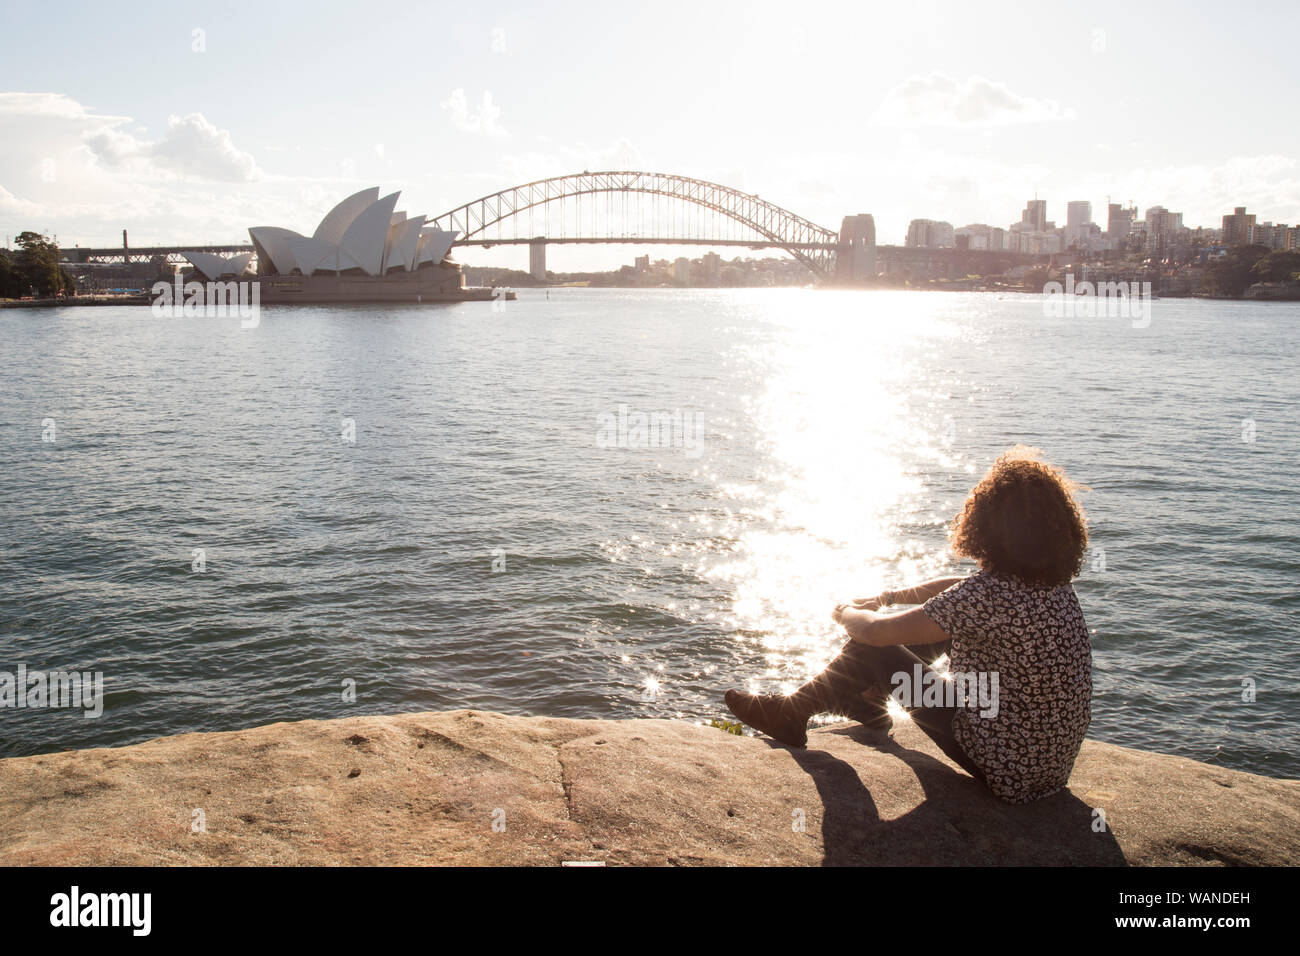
185, 186, 493, 303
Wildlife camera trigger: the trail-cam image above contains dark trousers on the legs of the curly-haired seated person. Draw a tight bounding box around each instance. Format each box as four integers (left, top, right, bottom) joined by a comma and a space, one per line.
792, 640, 984, 782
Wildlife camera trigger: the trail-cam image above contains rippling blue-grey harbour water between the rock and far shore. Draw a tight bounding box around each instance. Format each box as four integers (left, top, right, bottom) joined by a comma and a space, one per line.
0, 289, 1300, 777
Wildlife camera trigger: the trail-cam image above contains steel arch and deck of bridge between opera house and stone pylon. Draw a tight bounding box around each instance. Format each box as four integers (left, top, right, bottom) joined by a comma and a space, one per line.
430, 170, 839, 278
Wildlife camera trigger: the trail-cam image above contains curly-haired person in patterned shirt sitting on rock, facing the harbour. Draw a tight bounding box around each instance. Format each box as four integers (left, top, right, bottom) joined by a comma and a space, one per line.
725, 445, 1092, 803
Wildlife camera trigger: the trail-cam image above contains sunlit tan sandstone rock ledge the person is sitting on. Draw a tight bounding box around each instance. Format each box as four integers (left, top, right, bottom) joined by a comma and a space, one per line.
0, 710, 1300, 866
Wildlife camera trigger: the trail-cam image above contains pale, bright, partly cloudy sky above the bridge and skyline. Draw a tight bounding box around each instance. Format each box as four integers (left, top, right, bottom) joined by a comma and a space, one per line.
0, 0, 1300, 269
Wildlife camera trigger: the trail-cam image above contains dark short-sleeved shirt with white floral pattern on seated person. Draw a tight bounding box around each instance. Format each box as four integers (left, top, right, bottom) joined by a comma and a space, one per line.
923, 571, 1092, 804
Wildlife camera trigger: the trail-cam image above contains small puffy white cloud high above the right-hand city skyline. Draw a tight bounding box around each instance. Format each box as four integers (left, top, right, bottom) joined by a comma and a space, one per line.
874, 72, 1074, 127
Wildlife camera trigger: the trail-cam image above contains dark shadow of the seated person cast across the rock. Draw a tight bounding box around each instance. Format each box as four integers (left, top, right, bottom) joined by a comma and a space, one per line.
768, 723, 1127, 866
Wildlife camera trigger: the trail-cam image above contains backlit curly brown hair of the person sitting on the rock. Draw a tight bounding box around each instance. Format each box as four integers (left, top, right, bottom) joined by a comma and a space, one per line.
950, 445, 1088, 585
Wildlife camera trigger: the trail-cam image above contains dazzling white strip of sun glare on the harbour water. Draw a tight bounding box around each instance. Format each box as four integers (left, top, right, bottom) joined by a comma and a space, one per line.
710, 291, 954, 679
